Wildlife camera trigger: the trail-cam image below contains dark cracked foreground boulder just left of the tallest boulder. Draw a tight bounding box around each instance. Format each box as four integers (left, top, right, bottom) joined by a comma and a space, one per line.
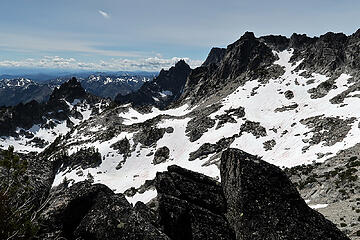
155, 166, 234, 240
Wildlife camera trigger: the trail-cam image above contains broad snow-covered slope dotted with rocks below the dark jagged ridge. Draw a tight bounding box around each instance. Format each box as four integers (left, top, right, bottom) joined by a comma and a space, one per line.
37, 49, 360, 204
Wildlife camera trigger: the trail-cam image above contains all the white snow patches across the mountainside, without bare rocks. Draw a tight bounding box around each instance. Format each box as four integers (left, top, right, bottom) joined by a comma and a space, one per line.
0, 50, 360, 203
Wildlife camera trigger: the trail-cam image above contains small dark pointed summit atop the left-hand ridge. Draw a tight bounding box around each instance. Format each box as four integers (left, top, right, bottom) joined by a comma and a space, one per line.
49, 77, 86, 102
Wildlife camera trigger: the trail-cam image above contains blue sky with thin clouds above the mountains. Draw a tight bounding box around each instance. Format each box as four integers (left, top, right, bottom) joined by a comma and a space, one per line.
0, 0, 360, 71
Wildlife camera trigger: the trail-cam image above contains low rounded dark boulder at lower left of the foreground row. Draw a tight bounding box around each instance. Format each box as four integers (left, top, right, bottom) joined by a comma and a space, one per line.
39, 182, 169, 240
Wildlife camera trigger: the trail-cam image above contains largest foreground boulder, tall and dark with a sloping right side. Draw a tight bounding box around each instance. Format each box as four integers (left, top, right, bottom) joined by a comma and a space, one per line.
220, 149, 349, 240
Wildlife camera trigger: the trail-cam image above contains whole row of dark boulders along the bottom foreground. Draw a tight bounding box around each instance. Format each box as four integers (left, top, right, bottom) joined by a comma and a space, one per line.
31, 149, 348, 240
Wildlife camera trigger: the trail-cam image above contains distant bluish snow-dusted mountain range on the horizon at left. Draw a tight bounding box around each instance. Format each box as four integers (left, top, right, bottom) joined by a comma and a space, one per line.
0, 72, 157, 106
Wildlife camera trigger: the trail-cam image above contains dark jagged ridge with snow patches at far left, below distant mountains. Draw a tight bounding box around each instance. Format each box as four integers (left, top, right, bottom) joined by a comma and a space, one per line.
0, 78, 110, 152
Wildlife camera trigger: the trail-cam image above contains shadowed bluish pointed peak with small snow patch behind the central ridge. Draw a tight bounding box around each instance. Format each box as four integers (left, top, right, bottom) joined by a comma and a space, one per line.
115, 60, 191, 108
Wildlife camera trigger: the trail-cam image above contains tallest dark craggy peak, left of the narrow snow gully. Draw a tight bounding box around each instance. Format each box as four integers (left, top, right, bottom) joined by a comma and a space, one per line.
180, 32, 278, 103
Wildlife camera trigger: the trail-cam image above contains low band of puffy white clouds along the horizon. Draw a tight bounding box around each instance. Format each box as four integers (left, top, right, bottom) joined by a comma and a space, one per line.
0, 56, 202, 71
